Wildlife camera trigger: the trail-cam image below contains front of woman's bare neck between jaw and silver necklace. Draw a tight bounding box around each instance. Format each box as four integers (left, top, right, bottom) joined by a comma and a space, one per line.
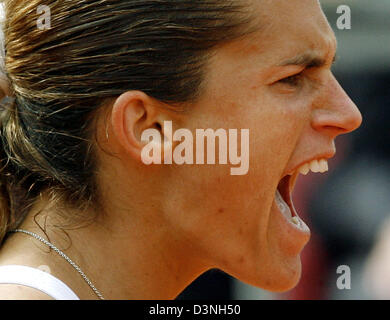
68, 210, 206, 300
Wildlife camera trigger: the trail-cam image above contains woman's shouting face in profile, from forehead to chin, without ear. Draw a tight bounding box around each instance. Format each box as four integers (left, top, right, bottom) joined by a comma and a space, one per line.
160, 0, 361, 291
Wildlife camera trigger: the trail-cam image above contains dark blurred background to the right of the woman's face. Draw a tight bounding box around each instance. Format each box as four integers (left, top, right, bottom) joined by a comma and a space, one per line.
178, 0, 390, 300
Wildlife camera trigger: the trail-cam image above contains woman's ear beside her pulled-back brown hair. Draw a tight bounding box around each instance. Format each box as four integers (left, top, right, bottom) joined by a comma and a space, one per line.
111, 91, 170, 161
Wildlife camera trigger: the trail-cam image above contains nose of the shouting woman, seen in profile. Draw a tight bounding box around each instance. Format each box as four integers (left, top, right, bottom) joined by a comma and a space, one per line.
312, 75, 362, 139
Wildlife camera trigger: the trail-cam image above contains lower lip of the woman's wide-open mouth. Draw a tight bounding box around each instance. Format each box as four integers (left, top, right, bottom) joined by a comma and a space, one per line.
273, 199, 310, 256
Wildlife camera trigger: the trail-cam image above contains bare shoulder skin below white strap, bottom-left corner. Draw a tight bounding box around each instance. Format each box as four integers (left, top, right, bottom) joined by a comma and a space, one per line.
0, 284, 54, 300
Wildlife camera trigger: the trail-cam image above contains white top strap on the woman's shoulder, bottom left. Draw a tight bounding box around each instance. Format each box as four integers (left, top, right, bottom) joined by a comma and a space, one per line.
0, 265, 80, 300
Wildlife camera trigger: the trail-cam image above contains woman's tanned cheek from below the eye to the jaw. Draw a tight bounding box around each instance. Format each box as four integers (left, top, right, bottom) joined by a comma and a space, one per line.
164, 89, 310, 263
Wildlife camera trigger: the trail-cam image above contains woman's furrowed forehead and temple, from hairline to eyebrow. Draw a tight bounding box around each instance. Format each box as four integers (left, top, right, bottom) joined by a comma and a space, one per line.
200, 0, 336, 99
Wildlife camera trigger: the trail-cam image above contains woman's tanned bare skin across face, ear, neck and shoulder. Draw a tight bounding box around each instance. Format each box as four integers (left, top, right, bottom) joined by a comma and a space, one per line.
0, 0, 362, 299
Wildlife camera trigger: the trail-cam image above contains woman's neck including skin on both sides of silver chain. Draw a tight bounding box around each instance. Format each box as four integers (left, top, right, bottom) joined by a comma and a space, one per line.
2, 198, 208, 300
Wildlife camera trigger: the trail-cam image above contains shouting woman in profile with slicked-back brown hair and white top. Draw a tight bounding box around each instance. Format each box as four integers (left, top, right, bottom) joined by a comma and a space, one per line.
0, 0, 361, 299
